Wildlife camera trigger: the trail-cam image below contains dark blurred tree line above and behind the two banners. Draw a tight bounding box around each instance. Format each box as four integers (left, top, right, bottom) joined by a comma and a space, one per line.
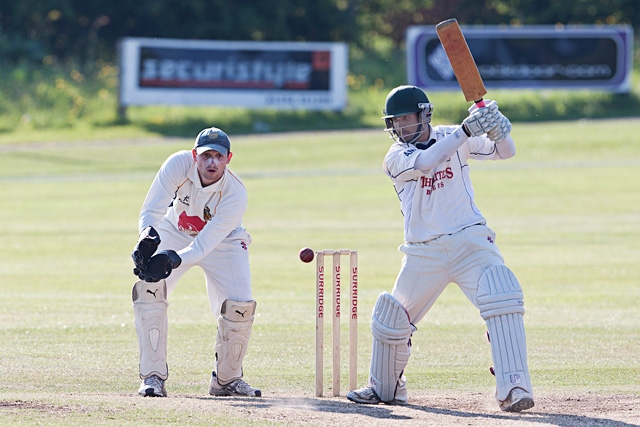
0, 0, 640, 67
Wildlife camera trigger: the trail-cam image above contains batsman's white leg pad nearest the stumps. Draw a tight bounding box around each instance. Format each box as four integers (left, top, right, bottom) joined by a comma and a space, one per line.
370, 292, 414, 402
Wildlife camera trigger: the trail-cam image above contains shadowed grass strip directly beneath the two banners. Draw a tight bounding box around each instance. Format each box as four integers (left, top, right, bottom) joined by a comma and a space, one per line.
119, 91, 640, 137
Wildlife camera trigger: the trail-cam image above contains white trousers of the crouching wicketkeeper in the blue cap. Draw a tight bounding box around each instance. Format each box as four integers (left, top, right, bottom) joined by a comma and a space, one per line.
158, 221, 253, 319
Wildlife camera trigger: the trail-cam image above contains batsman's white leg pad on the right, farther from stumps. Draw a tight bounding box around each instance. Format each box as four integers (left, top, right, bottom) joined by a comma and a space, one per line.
477, 265, 532, 402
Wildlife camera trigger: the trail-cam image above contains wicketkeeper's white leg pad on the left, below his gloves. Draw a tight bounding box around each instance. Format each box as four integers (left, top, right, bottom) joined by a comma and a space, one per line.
132, 280, 169, 380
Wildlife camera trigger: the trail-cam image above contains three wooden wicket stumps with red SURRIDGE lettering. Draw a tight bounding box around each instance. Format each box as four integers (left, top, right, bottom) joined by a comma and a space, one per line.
316, 249, 358, 397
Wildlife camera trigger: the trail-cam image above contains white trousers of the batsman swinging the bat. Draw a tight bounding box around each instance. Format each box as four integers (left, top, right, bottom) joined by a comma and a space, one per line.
391, 225, 504, 325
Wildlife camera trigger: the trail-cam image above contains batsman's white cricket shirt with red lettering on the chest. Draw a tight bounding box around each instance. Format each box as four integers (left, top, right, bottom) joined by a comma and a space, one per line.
382, 126, 515, 243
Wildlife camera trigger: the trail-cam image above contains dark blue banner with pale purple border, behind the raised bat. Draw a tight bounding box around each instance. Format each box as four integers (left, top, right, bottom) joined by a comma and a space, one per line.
407, 25, 633, 92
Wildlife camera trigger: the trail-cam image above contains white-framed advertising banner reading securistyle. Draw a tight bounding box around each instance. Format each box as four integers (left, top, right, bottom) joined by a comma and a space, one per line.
119, 38, 348, 110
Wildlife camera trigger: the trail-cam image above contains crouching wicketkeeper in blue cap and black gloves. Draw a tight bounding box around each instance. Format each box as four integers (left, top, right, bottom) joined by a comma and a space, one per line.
132, 128, 262, 397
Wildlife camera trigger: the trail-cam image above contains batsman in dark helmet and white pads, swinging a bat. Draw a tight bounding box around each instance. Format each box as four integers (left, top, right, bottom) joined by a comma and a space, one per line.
347, 86, 534, 412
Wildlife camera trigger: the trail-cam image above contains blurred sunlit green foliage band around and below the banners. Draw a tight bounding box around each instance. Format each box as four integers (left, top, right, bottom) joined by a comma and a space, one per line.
0, 57, 640, 142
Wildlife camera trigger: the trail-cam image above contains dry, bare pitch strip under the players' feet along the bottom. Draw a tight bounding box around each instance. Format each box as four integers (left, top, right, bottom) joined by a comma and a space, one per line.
0, 393, 640, 427
